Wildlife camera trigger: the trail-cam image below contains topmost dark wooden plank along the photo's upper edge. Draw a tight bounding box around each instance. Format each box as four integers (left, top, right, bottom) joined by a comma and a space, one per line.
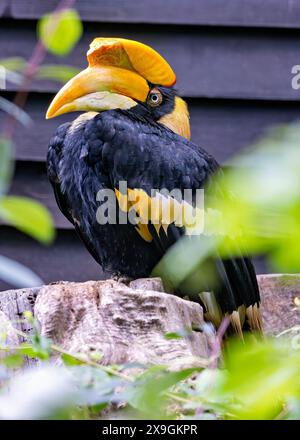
7, 0, 300, 28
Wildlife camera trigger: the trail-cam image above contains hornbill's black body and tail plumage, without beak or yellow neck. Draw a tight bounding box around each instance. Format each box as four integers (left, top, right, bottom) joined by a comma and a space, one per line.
47, 88, 260, 331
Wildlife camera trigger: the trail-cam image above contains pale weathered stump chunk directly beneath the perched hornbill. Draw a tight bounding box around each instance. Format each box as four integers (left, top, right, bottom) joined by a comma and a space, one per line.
35, 279, 208, 364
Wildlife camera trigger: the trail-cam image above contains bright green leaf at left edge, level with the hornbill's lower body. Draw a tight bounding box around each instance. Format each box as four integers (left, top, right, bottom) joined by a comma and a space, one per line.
0, 196, 54, 244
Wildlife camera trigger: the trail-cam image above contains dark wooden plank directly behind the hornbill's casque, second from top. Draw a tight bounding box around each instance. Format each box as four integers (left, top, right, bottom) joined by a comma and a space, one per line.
0, 20, 300, 100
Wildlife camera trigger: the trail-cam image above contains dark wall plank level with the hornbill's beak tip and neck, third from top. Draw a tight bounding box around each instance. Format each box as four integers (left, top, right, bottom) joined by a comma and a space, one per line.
0, 94, 299, 162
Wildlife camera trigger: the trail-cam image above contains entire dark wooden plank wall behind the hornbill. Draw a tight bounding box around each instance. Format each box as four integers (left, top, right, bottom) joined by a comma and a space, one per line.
0, 0, 300, 290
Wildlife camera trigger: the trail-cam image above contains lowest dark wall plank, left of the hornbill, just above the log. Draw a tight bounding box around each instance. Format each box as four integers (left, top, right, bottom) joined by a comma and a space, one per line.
0, 226, 105, 291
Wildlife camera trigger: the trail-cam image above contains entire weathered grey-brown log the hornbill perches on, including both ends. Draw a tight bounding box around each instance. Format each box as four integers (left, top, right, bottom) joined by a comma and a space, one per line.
0, 275, 300, 365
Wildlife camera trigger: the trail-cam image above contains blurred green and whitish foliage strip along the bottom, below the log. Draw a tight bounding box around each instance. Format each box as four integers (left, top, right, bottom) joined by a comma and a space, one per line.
0, 310, 300, 420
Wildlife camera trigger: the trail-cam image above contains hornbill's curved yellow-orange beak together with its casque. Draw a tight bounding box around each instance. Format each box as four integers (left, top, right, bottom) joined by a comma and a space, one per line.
46, 38, 176, 119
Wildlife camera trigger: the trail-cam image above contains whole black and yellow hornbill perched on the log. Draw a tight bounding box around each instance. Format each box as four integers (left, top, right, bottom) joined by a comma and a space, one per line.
47, 38, 261, 333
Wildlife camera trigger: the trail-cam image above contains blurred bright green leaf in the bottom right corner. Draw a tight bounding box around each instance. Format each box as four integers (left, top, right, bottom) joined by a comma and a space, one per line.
213, 340, 300, 420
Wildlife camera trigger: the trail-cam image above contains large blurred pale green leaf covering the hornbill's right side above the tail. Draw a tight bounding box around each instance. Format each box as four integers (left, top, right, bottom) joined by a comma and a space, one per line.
153, 123, 300, 293
